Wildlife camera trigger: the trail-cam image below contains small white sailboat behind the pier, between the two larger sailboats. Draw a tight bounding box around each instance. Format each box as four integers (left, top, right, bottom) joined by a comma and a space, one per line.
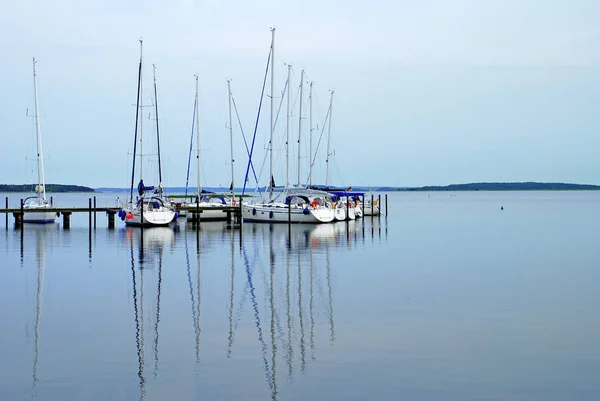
184, 75, 233, 221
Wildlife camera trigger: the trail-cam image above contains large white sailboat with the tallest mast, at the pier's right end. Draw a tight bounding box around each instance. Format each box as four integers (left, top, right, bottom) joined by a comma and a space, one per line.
242, 28, 334, 223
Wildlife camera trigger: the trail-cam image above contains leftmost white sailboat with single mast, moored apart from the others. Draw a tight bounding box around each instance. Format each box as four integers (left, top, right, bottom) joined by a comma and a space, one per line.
23, 58, 56, 224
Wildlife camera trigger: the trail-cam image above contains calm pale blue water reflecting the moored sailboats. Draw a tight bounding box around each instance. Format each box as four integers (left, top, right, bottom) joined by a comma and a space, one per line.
0, 192, 600, 401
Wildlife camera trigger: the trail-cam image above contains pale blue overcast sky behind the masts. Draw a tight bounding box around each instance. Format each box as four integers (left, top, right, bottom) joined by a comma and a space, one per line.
0, 0, 600, 187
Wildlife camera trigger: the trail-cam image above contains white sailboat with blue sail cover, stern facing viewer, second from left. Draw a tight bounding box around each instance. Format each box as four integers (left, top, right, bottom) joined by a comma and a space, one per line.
118, 39, 178, 227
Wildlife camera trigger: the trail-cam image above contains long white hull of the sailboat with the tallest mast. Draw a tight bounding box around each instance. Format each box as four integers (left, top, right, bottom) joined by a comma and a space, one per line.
242, 202, 334, 223
